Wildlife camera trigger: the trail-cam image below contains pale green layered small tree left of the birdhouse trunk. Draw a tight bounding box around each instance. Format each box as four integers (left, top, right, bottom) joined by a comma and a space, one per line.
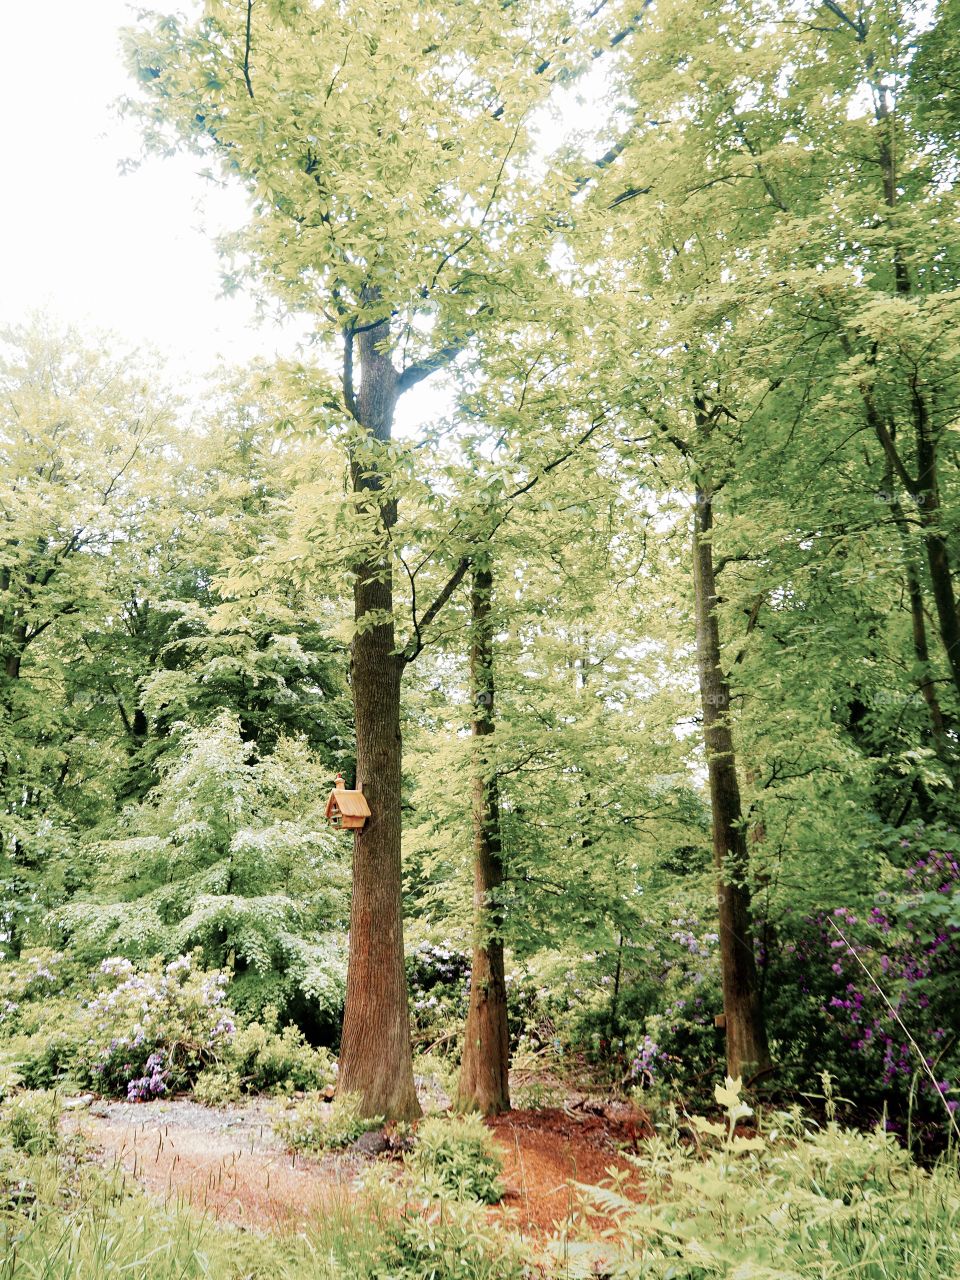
58, 713, 346, 1037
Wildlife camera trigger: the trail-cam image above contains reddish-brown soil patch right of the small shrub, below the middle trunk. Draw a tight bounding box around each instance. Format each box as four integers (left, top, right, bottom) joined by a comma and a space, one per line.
490, 1107, 653, 1236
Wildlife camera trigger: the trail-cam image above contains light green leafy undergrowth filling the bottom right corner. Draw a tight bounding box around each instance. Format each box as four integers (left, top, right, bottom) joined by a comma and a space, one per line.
571, 1080, 960, 1280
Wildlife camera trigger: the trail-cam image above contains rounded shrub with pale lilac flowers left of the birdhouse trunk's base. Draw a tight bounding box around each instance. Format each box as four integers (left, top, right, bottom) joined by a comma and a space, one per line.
76, 956, 236, 1102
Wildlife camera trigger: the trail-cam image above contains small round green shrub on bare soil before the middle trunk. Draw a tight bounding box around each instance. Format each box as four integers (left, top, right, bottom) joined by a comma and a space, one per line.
407, 1115, 503, 1204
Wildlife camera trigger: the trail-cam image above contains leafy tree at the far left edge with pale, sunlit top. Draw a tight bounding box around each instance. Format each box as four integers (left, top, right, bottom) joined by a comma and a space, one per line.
0, 320, 169, 951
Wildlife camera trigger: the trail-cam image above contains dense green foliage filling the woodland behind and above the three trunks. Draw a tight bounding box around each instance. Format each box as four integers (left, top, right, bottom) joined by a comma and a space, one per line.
0, 0, 960, 1152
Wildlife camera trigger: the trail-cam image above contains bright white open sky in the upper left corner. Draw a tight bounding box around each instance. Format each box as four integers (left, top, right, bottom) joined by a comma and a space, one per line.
0, 0, 293, 376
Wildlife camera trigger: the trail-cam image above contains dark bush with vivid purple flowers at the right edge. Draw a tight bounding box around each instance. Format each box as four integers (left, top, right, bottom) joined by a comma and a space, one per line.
763, 832, 960, 1129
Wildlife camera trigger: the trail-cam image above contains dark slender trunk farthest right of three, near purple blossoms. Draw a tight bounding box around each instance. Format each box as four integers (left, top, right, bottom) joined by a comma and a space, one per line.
694, 489, 771, 1078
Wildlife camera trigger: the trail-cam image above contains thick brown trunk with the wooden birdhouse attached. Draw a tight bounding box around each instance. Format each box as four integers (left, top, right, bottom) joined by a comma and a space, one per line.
339, 312, 420, 1120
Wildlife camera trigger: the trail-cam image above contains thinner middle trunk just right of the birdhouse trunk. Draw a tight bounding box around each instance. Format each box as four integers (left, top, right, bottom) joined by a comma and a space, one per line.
457, 564, 509, 1115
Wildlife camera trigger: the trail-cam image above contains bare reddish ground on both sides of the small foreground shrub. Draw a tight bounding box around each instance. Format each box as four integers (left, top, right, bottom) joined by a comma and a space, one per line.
65, 1096, 652, 1239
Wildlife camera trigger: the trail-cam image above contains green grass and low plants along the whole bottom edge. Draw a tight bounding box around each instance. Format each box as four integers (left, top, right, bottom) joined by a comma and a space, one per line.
0, 1082, 960, 1280
